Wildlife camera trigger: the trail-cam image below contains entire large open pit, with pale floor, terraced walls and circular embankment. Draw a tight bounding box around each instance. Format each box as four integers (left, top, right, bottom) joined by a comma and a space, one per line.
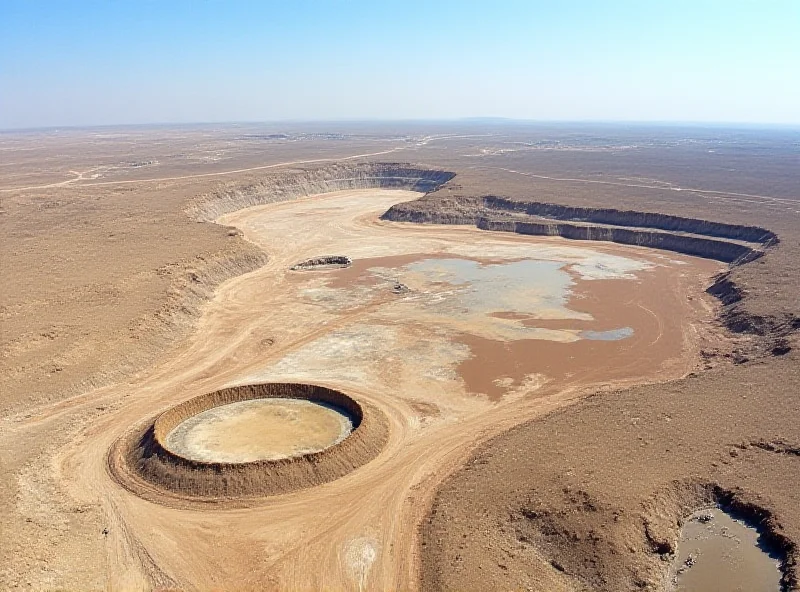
76, 164, 776, 589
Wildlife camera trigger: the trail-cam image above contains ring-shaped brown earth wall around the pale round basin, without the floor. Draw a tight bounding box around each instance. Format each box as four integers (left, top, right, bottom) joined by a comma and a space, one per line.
109, 383, 389, 499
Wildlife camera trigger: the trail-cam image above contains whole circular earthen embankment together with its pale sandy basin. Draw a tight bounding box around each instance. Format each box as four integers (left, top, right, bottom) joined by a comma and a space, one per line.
108, 383, 389, 500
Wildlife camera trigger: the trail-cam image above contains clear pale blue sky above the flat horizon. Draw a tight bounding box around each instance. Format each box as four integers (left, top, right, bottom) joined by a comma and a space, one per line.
0, 0, 800, 128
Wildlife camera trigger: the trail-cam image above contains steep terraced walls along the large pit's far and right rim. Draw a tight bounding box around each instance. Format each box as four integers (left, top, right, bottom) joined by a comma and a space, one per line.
187, 162, 780, 334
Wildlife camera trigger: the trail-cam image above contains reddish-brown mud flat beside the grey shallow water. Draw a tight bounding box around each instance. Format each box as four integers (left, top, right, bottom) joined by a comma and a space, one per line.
458, 271, 683, 400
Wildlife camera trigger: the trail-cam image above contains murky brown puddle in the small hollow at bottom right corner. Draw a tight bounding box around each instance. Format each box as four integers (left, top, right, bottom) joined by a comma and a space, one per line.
670, 508, 781, 592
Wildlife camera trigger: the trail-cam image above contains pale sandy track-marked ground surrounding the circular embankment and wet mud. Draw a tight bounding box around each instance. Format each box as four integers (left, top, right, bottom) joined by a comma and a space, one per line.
12, 190, 719, 590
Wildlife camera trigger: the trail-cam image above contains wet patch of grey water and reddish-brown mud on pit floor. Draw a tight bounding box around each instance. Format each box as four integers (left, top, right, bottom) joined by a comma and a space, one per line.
310, 253, 711, 400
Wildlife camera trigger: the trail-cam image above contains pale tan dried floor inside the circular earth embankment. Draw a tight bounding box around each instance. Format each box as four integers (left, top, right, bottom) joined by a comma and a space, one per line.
166, 399, 353, 463
